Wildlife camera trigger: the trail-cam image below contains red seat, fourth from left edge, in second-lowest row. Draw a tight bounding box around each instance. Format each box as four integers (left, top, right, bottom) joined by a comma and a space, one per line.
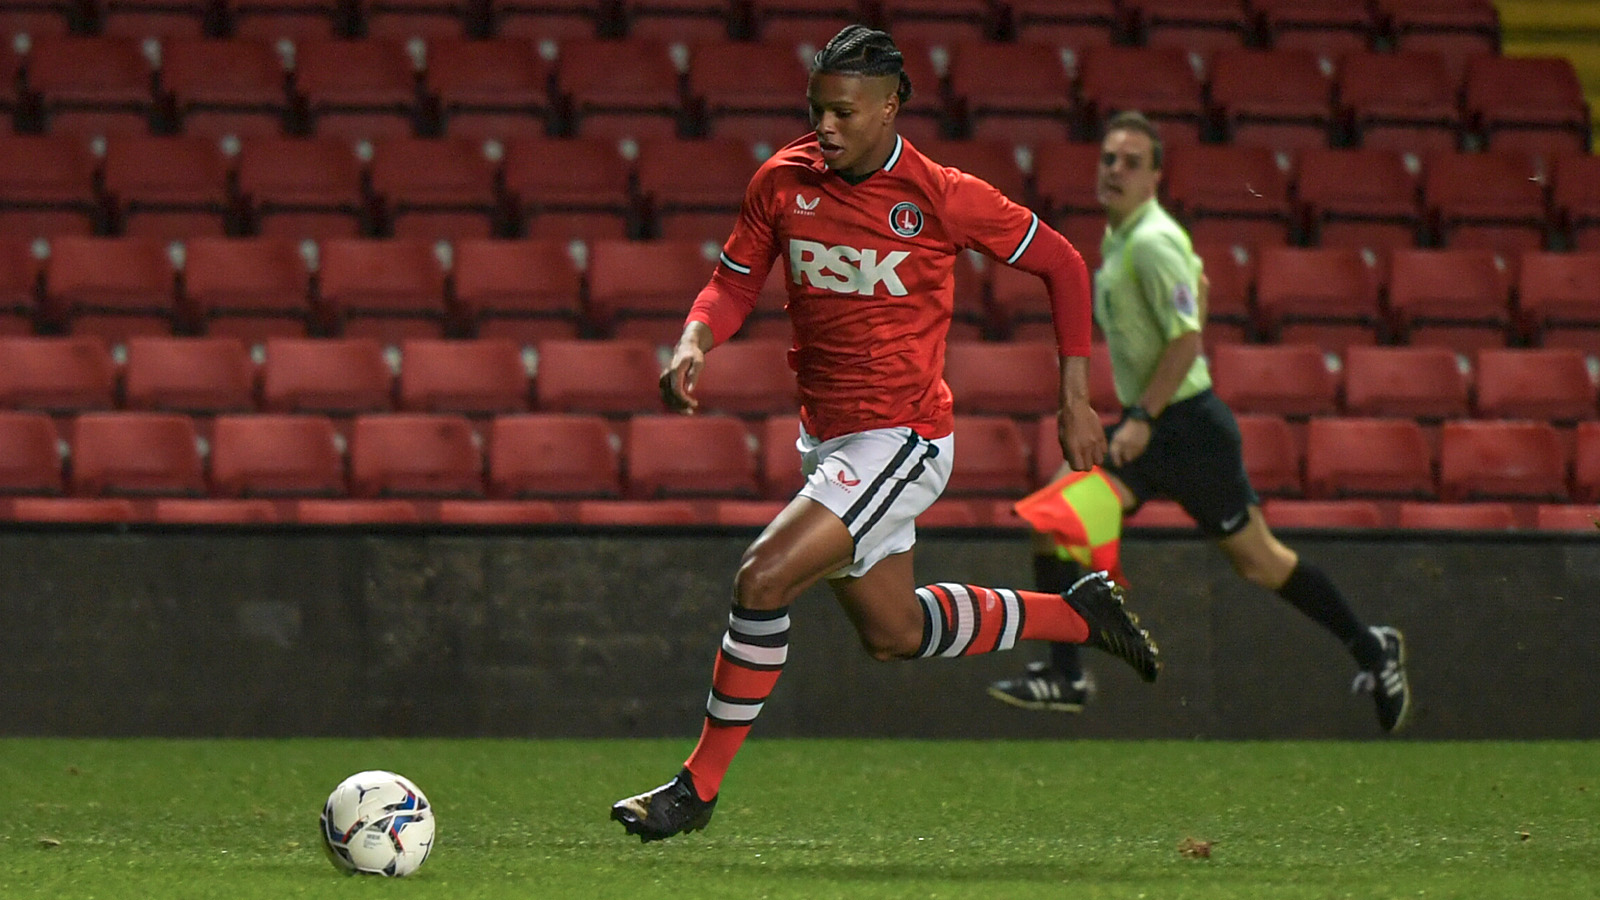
400, 338, 530, 415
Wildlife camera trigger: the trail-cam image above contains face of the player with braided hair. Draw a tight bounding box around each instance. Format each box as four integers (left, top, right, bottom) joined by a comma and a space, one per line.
805, 72, 899, 176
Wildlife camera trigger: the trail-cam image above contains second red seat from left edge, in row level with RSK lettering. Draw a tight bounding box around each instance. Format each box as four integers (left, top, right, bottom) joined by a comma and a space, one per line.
43, 235, 179, 341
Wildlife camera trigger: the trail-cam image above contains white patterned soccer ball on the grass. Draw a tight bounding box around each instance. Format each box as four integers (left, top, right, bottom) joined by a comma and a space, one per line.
322, 770, 434, 878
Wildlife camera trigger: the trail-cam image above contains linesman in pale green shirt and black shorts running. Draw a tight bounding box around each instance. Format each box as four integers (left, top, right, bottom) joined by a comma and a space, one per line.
989, 112, 1411, 732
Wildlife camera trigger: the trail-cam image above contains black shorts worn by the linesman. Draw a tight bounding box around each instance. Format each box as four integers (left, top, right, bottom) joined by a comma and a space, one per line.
1106, 391, 1261, 538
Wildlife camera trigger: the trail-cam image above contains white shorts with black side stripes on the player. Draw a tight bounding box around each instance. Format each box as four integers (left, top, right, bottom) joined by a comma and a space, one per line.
795, 428, 955, 578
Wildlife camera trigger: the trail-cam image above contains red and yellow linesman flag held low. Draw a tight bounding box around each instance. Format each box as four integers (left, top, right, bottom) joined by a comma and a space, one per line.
1013, 466, 1128, 586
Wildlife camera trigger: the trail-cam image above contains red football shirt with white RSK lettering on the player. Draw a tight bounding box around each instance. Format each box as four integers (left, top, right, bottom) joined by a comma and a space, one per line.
690, 135, 1088, 440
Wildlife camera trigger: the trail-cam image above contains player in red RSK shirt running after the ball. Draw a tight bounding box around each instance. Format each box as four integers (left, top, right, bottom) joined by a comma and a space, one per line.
611, 26, 1157, 841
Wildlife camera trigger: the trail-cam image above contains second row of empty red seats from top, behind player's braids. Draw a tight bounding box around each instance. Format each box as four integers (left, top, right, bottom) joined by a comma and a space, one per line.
8, 35, 1589, 151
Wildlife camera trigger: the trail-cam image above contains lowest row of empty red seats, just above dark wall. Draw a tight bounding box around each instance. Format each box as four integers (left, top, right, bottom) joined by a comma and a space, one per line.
0, 412, 1600, 501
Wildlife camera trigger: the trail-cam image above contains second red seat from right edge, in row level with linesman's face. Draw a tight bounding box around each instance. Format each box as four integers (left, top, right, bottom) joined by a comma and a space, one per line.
1422, 151, 1546, 251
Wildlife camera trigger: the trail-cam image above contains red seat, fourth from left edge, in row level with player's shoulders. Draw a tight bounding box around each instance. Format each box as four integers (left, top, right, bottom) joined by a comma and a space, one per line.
371, 138, 506, 237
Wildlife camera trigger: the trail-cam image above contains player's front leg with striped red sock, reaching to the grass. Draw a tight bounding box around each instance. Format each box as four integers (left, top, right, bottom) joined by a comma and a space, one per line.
611, 496, 854, 841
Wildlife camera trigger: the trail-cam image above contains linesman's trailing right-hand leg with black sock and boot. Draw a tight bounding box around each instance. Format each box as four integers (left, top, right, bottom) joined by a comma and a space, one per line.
1219, 506, 1411, 732
